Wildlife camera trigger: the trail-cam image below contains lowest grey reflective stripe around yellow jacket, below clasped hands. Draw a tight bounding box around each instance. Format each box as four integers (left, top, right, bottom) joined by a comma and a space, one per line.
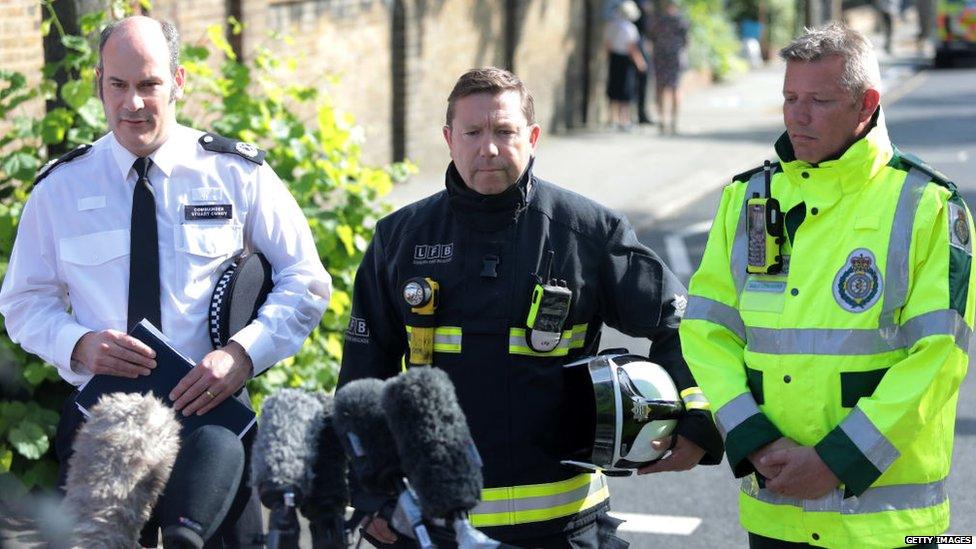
741, 475, 949, 515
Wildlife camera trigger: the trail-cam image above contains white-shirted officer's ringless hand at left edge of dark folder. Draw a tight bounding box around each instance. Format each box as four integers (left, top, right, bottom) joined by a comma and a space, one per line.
71, 330, 156, 378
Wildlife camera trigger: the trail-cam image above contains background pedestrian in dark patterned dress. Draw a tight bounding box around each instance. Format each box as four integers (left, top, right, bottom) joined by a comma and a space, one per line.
647, 0, 689, 135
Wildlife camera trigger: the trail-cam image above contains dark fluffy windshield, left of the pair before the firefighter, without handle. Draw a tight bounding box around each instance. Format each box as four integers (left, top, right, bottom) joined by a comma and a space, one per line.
333, 378, 402, 494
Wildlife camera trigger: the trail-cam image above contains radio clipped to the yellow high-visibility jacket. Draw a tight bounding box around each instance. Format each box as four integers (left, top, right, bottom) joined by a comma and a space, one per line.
746, 160, 783, 275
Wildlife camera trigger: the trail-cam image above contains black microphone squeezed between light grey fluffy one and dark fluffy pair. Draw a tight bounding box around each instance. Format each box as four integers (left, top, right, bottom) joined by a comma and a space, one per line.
301, 393, 349, 549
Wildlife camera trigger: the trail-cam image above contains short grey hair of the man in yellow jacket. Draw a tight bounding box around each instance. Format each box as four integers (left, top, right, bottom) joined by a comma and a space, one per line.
779, 22, 881, 99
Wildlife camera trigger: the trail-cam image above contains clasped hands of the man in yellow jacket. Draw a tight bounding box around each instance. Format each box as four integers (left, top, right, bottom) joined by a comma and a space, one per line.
761, 446, 840, 499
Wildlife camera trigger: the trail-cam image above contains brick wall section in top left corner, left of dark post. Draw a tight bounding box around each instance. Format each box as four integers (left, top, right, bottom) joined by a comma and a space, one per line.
0, 0, 44, 137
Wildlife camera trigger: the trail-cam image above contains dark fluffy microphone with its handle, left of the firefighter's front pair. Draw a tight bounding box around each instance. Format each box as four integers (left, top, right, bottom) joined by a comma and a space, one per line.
333, 378, 434, 549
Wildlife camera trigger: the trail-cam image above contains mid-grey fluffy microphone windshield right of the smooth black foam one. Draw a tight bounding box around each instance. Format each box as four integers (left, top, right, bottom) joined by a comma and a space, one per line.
251, 389, 323, 508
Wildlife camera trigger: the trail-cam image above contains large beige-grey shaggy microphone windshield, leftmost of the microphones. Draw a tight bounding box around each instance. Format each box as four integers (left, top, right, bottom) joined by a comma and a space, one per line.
62, 393, 180, 549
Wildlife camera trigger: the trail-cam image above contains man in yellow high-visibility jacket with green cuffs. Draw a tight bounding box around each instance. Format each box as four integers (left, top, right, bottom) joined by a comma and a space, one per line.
680, 24, 976, 548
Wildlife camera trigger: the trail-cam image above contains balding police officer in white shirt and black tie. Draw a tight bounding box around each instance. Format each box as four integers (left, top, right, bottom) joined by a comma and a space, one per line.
0, 17, 331, 544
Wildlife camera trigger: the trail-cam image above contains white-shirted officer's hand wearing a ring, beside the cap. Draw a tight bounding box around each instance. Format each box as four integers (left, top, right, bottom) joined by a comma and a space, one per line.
169, 341, 253, 416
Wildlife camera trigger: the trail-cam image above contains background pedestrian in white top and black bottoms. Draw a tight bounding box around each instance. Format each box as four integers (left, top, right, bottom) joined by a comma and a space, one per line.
604, 0, 647, 130
